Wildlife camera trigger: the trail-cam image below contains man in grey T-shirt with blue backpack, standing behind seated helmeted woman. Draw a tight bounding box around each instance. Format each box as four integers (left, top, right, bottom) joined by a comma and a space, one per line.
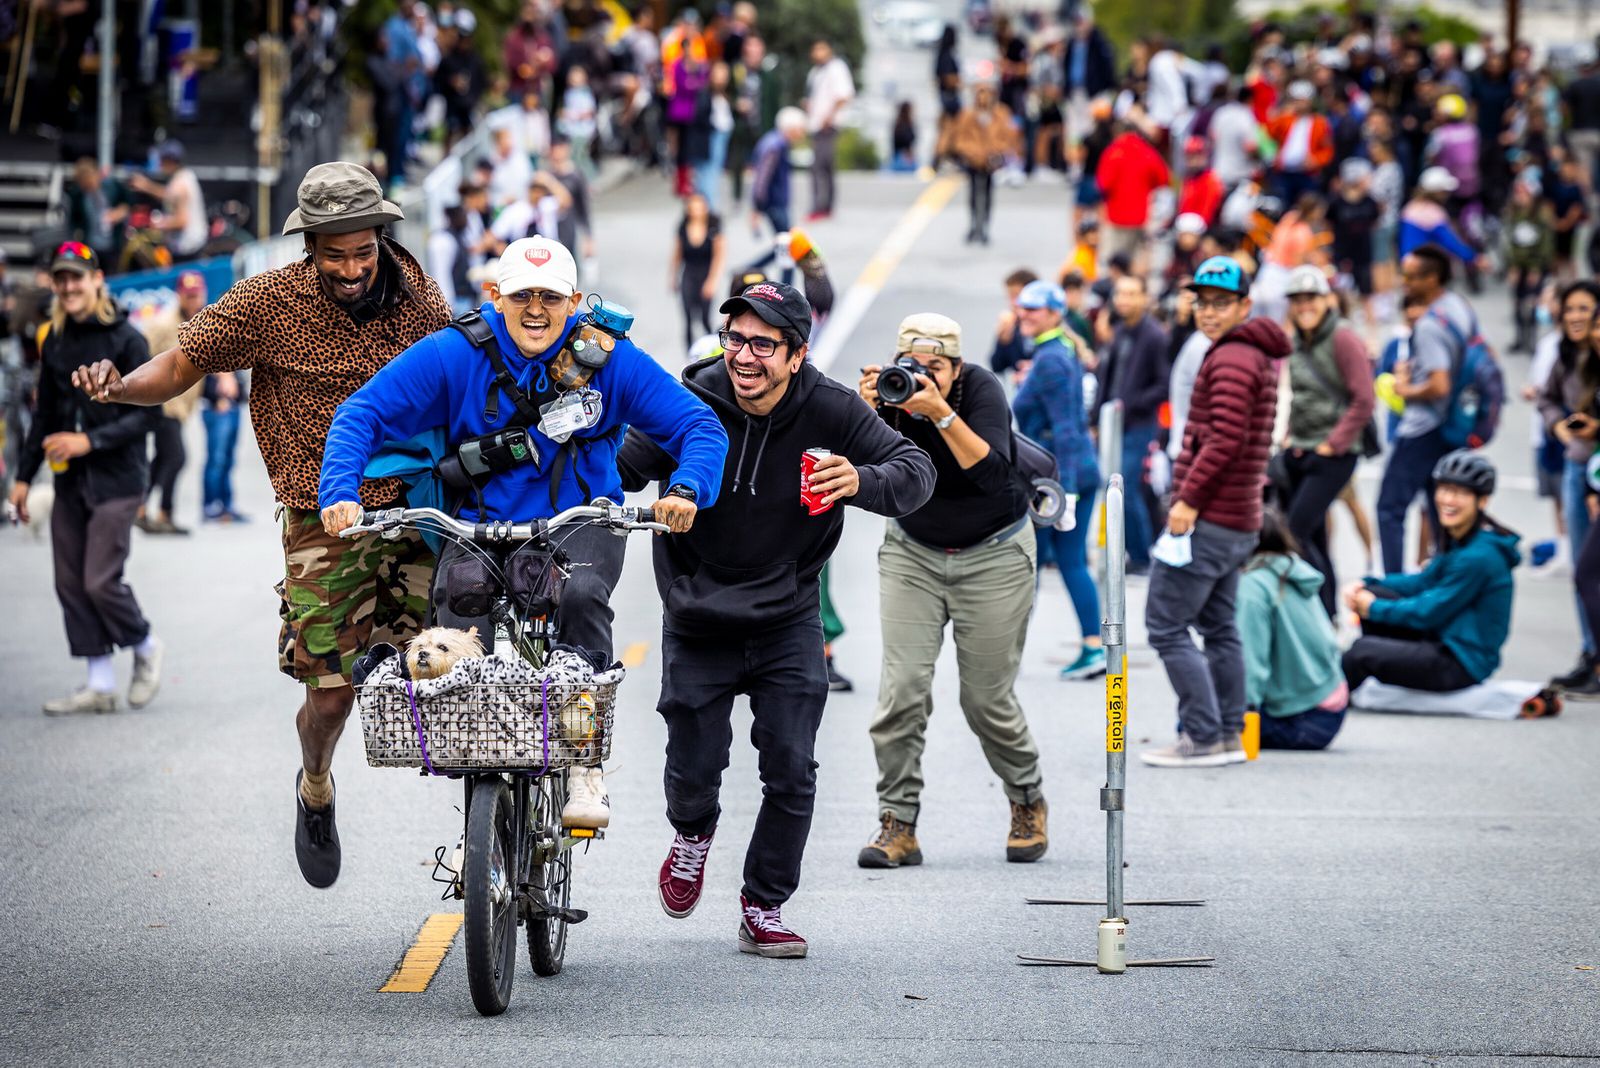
1378, 245, 1478, 572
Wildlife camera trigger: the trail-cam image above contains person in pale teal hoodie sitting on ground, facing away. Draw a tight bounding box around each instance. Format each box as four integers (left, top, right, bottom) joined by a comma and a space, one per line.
1237, 508, 1350, 750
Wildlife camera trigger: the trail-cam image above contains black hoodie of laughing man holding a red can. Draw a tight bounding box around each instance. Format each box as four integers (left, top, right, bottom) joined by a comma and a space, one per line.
618, 357, 934, 636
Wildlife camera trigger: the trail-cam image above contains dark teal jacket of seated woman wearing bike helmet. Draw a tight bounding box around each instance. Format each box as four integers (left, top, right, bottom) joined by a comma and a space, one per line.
1366, 526, 1522, 683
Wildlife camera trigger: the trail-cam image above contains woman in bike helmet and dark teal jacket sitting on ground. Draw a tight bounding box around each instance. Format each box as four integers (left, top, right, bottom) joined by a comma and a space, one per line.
1344, 449, 1522, 692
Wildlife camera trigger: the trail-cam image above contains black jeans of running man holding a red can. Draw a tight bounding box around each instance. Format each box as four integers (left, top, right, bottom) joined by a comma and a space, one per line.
656, 617, 827, 908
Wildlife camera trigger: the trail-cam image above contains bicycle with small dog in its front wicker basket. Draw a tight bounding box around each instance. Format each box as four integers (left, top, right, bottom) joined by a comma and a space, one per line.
342, 497, 667, 1015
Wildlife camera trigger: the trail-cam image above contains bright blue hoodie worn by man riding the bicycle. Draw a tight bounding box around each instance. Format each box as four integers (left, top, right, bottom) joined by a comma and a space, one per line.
318, 304, 728, 521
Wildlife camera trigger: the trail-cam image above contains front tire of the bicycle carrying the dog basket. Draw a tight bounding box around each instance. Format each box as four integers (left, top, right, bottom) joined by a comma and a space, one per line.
461, 775, 517, 1017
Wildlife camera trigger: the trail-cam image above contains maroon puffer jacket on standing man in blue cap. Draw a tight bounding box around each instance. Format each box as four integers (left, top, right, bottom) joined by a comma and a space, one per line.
1173, 318, 1291, 532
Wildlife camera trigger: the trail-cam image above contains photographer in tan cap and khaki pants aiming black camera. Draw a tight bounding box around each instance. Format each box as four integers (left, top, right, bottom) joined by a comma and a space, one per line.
858, 313, 1048, 868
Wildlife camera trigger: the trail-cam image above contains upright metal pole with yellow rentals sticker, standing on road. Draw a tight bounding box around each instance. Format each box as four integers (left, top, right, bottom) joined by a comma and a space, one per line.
1099, 473, 1128, 972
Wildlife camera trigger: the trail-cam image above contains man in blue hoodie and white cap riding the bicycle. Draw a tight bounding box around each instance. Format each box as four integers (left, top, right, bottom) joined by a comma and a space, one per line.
318, 237, 728, 828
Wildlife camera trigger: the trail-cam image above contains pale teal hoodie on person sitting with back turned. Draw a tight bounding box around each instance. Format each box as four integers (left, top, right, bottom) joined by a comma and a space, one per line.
1237, 553, 1339, 716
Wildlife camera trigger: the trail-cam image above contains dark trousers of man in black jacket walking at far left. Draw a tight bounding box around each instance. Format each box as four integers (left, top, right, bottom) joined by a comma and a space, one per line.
50, 478, 150, 657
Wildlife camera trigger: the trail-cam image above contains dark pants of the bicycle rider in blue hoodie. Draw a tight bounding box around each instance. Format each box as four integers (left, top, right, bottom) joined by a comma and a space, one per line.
434, 526, 627, 664
